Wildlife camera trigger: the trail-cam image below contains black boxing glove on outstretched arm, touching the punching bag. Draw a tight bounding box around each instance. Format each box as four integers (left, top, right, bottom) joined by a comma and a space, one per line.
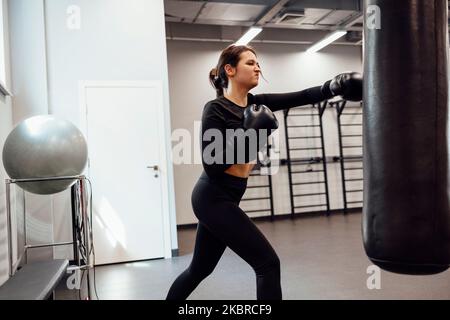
322, 72, 363, 101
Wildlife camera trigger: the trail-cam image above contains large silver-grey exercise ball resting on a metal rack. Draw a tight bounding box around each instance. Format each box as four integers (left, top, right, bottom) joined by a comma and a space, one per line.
3, 115, 87, 194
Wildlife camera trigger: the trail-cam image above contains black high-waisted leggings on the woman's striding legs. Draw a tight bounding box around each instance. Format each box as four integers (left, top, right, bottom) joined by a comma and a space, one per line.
166, 172, 282, 300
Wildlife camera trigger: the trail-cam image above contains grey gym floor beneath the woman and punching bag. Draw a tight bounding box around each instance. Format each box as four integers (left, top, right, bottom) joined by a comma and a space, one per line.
56, 213, 450, 300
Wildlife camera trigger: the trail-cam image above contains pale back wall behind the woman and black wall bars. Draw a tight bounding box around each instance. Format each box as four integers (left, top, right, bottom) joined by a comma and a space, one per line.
167, 40, 362, 225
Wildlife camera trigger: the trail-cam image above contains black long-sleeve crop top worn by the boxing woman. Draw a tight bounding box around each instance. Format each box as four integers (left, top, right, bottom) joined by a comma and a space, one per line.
201, 85, 333, 177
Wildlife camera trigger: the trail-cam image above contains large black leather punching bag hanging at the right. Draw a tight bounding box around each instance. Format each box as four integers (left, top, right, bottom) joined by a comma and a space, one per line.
362, 0, 450, 274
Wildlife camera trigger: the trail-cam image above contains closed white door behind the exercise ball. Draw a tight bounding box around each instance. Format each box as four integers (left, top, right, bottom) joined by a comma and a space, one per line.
84, 82, 164, 264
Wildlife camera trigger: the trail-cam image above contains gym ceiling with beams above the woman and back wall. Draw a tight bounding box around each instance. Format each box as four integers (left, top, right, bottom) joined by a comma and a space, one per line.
164, 0, 363, 45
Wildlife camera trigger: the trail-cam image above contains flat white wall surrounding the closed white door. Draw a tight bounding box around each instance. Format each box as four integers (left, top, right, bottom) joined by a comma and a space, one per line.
45, 0, 177, 258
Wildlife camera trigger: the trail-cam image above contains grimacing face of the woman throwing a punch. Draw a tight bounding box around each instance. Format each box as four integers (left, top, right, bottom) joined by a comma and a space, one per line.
228, 51, 261, 90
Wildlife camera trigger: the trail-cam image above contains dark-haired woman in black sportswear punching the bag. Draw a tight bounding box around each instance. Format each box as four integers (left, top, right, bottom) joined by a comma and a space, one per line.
167, 45, 362, 300
